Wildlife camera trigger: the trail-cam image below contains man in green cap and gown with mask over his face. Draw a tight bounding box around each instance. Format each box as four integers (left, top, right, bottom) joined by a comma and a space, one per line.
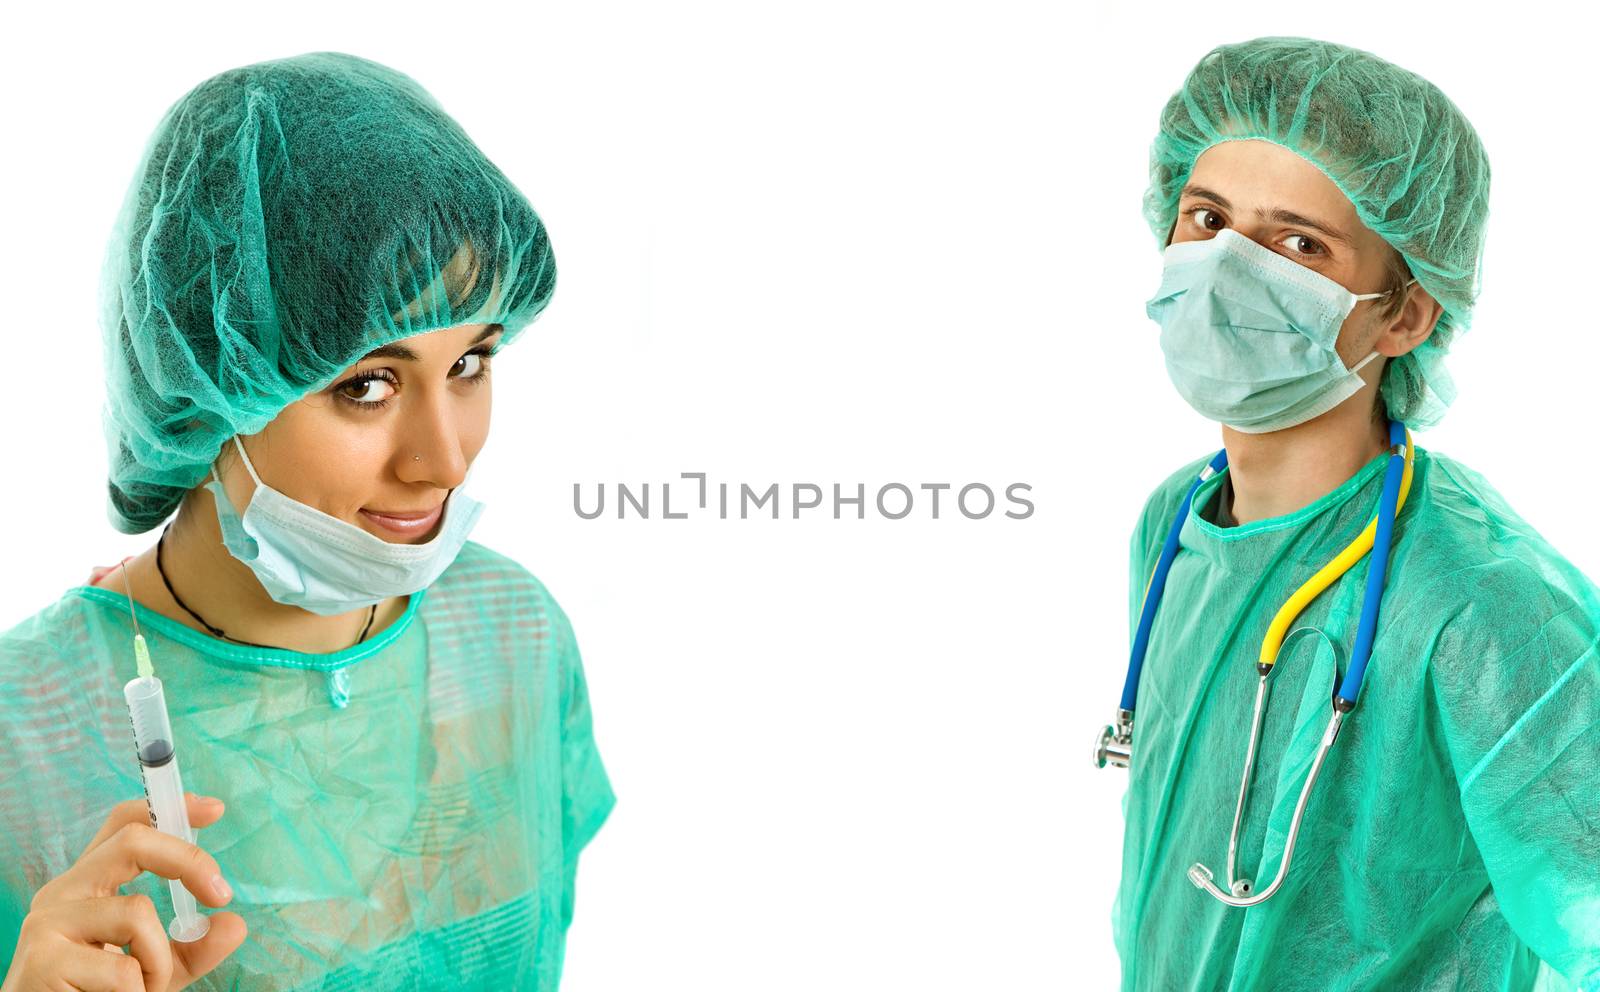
1099, 38, 1600, 992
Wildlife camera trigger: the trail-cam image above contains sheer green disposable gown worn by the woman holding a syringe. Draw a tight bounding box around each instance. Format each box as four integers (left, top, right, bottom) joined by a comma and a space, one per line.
0, 541, 614, 990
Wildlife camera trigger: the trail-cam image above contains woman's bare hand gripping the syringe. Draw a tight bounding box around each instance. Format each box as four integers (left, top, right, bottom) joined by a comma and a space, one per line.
0, 792, 245, 992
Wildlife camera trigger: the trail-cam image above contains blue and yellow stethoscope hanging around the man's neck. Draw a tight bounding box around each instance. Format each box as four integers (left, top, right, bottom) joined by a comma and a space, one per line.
1094, 419, 1413, 906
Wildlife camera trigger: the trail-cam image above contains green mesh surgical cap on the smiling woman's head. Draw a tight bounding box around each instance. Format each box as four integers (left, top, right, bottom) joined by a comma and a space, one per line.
101, 51, 555, 534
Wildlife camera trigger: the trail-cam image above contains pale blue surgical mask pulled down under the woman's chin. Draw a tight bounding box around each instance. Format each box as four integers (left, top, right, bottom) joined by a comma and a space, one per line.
205, 437, 483, 616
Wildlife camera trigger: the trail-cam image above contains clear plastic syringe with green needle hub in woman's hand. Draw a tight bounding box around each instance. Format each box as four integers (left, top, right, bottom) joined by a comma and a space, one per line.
122, 563, 211, 942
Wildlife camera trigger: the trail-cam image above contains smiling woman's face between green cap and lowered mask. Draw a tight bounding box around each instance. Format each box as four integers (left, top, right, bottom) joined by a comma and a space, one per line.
218, 323, 504, 544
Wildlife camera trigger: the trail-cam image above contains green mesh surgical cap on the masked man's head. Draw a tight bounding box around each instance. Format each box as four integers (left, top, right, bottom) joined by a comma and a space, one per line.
1144, 38, 1490, 430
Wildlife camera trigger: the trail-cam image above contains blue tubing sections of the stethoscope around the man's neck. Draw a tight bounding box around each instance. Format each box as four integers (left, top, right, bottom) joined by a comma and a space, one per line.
1122, 419, 1406, 712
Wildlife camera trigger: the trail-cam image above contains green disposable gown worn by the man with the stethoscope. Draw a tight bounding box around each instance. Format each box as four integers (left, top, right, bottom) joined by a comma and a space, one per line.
1112, 448, 1600, 992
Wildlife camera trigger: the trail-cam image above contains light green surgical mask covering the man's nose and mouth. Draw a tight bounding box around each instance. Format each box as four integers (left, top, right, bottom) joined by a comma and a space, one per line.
1144, 227, 1416, 434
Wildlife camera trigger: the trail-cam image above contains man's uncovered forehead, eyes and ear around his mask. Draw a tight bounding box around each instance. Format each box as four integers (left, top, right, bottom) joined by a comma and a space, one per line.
1171, 139, 1389, 384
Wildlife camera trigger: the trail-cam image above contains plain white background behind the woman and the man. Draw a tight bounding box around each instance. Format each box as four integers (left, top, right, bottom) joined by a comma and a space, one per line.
0, 2, 1600, 992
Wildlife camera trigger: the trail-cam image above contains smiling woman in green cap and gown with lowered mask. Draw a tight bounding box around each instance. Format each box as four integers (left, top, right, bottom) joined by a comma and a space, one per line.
0, 53, 613, 990
